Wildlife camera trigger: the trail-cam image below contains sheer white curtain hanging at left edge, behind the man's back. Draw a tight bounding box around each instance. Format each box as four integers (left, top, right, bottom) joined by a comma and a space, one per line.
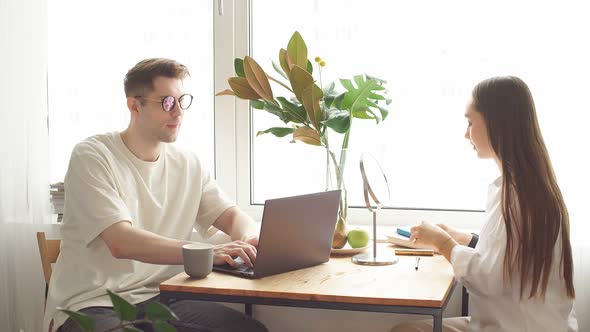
0, 0, 50, 332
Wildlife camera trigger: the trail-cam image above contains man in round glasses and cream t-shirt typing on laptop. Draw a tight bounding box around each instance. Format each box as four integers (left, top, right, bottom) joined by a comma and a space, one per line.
45, 58, 266, 332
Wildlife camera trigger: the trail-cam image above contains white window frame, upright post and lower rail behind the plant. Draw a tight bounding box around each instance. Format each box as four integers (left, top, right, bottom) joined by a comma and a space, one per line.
214, 0, 484, 230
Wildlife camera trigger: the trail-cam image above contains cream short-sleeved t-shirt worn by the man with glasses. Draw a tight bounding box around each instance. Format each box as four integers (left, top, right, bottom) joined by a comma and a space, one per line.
44, 132, 234, 331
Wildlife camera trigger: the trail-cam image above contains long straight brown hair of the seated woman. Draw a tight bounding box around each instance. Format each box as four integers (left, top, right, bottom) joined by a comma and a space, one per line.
472, 76, 575, 299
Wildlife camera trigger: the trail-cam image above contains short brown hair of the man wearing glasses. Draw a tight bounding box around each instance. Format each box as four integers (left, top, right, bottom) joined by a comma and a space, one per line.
124, 58, 190, 97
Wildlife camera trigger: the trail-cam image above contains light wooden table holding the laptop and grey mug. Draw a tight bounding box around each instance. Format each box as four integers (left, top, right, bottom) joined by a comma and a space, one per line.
160, 244, 456, 332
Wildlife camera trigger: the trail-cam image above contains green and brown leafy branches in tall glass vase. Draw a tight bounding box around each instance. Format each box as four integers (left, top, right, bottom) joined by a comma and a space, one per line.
216, 31, 391, 248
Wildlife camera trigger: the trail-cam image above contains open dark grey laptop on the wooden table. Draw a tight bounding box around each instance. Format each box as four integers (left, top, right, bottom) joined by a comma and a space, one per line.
213, 190, 340, 279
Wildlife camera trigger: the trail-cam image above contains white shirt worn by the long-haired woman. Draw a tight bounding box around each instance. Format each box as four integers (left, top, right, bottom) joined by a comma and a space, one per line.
451, 177, 578, 332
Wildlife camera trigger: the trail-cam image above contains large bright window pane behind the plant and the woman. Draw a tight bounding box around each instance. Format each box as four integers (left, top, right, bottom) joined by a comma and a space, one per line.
252, 0, 590, 218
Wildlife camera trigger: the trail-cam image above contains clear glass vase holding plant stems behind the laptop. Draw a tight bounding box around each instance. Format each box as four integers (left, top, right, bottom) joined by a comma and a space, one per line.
326, 148, 348, 249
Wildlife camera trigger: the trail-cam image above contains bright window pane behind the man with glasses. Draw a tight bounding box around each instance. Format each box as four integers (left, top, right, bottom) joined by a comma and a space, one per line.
48, 0, 214, 181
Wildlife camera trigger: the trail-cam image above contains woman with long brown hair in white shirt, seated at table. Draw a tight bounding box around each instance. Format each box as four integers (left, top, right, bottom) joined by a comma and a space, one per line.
393, 77, 578, 332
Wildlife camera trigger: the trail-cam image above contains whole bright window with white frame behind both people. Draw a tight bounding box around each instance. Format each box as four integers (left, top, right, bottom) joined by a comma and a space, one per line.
48, 0, 590, 238
